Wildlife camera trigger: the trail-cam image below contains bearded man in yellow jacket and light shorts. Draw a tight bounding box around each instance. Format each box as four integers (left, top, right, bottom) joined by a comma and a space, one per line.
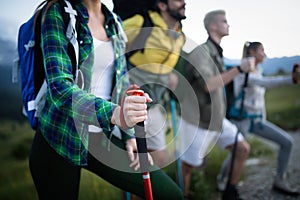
120, 0, 186, 167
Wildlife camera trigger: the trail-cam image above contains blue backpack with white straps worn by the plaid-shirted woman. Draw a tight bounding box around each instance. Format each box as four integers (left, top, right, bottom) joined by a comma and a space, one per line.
13, 0, 79, 130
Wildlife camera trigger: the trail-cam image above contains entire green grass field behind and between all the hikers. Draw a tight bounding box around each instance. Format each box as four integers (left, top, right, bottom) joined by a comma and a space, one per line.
0, 85, 300, 200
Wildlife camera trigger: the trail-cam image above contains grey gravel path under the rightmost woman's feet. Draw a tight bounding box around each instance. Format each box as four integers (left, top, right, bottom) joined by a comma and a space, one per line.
239, 130, 300, 200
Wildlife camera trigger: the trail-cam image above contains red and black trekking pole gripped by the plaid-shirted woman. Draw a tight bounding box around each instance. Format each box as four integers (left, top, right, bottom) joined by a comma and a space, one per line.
127, 89, 153, 200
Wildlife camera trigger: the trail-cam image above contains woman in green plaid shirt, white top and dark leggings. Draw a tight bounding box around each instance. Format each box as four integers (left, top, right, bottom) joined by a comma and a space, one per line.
29, 0, 182, 199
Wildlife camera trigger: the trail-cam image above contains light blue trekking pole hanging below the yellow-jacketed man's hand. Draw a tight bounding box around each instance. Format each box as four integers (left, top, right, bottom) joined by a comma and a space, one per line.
170, 94, 183, 190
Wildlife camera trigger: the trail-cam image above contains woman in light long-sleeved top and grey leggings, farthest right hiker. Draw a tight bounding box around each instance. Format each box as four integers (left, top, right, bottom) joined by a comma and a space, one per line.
226, 42, 300, 194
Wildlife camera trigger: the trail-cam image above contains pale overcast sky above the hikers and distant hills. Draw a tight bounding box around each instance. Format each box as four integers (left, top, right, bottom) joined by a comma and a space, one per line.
0, 0, 300, 58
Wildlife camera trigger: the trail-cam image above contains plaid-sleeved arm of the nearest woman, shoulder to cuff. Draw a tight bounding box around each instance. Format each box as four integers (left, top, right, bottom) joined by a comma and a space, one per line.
41, 4, 116, 130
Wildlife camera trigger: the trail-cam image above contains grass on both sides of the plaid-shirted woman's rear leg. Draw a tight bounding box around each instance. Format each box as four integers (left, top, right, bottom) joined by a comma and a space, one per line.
0, 121, 122, 200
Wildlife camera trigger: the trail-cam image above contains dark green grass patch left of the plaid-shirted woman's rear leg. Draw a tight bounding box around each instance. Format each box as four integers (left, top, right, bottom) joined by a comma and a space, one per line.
0, 122, 37, 200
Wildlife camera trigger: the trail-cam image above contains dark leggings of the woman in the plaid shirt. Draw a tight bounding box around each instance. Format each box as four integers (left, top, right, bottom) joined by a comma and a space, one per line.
29, 132, 183, 200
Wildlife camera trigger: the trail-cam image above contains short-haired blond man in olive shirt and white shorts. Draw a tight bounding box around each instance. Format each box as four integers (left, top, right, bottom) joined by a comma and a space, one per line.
179, 10, 250, 200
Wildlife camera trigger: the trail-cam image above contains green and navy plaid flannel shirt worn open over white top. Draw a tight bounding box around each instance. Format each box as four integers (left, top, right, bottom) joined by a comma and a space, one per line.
39, 3, 133, 165
